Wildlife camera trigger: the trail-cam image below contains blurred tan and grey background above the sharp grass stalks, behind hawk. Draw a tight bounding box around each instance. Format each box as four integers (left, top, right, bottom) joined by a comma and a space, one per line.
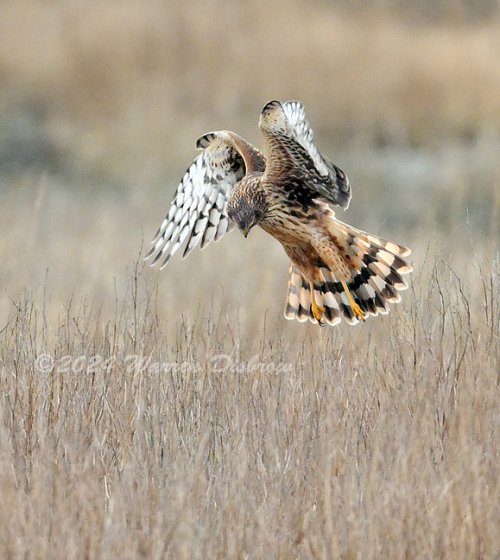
0, 0, 500, 323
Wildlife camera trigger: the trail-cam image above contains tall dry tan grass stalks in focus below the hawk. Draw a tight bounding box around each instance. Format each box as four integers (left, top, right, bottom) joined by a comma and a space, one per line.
0, 243, 500, 559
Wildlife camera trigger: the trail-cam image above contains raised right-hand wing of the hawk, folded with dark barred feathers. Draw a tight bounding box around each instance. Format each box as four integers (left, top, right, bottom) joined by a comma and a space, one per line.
260, 101, 351, 207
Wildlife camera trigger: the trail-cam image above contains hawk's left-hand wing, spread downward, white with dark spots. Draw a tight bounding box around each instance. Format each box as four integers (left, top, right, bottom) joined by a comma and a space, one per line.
146, 131, 265, 268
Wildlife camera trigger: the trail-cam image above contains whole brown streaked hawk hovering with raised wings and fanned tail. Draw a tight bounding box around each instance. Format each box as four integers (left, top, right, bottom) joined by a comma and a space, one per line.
146, 101, 411, 325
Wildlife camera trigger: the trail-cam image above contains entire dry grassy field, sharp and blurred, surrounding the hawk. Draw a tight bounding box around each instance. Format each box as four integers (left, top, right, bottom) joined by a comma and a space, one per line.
0, 0, 500, 560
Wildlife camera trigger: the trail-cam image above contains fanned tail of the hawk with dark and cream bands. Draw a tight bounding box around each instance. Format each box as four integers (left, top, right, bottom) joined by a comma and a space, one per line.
285, 219, 412, 325
